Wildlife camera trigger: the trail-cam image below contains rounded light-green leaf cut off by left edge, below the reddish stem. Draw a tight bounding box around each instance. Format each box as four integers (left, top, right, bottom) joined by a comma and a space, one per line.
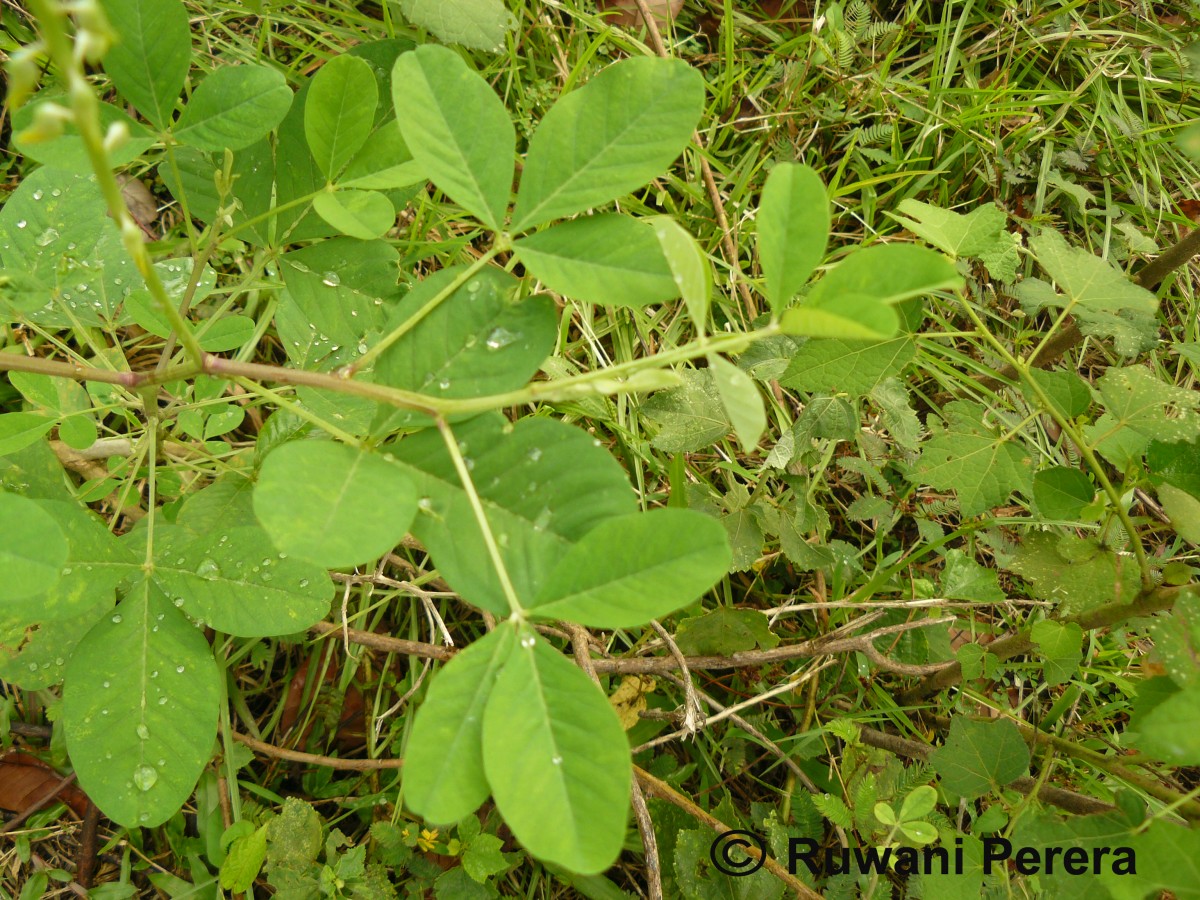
0, 492, 70, 604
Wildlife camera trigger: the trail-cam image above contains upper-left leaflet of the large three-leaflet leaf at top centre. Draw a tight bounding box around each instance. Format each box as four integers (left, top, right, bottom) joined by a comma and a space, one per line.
391, 44, 516, 232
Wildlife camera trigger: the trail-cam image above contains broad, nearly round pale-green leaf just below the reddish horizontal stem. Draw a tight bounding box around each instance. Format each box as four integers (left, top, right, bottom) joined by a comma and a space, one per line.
254, 440, 416, 569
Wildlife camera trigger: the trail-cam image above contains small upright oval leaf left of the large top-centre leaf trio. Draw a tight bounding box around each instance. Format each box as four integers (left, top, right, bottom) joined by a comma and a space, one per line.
304, 54, 379, 181
